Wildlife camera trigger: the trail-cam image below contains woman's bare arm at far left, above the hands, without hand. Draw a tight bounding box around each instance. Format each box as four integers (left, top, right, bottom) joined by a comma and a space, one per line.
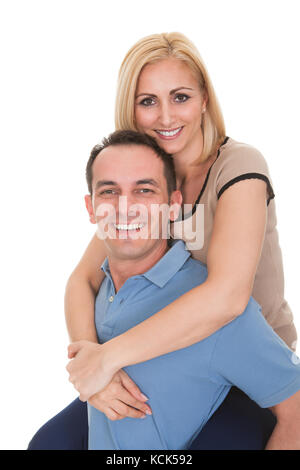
65, 234, 106, 343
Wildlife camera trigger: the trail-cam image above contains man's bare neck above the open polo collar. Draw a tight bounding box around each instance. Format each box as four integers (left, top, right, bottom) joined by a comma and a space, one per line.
107, 240, 169, 292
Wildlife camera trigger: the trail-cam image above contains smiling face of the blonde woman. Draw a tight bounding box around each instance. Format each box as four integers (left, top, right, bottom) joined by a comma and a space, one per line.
135, 58, 206, 154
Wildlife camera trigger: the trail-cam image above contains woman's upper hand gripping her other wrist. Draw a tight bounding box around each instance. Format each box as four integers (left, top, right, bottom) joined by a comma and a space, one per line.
66, 340, 116, 401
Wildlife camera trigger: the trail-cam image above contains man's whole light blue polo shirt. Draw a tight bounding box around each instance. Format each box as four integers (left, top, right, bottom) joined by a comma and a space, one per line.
88, 240, 300, 450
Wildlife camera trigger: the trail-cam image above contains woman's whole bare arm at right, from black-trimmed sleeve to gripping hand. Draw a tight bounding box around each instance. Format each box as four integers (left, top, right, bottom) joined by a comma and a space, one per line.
69, 179, 267, 400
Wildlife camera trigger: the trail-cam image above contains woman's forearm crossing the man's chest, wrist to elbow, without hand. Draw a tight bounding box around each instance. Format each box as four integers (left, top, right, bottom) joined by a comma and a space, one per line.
103, 281, 245, 371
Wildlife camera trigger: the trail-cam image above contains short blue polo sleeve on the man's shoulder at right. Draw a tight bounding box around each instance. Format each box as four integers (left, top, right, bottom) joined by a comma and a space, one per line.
210, 297, 300, 408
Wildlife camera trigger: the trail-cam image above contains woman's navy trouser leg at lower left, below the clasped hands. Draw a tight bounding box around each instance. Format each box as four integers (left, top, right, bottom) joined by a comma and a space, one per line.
28, 398, 88, 450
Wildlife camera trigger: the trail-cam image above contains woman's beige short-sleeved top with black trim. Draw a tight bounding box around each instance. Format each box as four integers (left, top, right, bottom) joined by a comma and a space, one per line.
171, 137, 297, 349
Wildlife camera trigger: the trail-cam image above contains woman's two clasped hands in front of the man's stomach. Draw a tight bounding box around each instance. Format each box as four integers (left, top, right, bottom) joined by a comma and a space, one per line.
66, 340, 152, 420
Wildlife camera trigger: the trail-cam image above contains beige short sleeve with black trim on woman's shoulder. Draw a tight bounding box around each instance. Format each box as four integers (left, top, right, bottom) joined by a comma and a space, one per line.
216, 141, 275, 204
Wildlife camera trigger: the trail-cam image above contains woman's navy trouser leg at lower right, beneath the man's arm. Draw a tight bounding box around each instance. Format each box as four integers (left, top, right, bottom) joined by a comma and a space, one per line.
189, 387, 276, 450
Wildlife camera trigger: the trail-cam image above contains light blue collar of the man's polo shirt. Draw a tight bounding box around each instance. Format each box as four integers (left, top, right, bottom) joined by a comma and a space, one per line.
101, 240, 191, 287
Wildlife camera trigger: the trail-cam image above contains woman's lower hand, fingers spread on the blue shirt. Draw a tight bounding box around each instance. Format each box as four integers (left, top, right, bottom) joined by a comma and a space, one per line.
89, 370, 152, 421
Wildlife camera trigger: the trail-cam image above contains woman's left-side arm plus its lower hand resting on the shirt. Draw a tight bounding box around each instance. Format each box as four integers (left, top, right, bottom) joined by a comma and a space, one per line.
65, 235, 151, 420
